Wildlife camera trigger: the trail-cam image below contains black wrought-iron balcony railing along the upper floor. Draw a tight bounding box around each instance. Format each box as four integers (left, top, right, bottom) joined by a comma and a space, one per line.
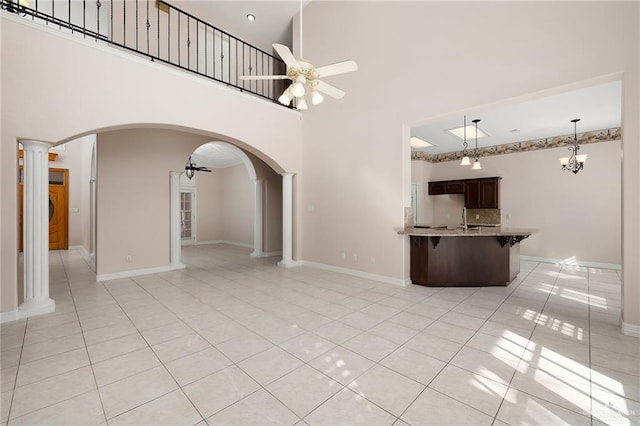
0, 0, 286, 105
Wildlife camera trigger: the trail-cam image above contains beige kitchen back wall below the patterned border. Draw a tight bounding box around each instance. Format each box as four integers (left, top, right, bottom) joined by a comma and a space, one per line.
412, 141, 621, 265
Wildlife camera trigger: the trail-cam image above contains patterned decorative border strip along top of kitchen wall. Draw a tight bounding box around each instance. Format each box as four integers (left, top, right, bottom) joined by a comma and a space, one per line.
411, 127, 622, 163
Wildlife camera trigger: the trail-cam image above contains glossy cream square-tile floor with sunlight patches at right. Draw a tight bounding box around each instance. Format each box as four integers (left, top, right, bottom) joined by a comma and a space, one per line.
0, 245, 640, 425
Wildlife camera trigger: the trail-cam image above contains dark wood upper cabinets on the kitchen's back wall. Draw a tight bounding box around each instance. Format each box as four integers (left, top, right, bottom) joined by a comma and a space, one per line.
429, 177, 502, 209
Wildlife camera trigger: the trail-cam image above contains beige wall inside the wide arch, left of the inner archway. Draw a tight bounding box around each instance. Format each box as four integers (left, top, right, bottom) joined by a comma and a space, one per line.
96, 129, 211, 275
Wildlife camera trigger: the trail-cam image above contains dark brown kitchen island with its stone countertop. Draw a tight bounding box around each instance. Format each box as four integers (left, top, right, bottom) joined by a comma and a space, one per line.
399, 226, 535, 287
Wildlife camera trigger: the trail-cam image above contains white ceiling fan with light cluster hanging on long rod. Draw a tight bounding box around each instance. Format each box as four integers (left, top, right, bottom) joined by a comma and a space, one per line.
240, 0, 358, 110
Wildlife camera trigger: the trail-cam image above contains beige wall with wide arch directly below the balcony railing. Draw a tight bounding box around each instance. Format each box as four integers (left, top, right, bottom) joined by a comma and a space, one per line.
0, 14, 302, 313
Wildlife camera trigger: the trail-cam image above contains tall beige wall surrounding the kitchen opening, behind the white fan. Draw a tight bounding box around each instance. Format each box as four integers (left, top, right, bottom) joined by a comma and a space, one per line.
300, 1, 640, 325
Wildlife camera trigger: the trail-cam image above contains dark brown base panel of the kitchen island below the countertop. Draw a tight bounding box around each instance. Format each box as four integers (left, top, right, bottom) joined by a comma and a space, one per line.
411, 236, 519, 287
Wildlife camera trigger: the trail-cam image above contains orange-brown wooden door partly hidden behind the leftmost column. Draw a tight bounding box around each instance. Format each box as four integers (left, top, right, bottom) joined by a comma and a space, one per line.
18, 166, 69, 251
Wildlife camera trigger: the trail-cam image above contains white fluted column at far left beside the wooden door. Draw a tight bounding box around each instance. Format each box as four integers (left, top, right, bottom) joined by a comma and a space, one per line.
18, 140, 56, 318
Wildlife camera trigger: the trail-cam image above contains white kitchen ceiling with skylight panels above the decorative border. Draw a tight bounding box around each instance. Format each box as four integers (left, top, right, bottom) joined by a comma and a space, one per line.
411, 81, 622, 154
